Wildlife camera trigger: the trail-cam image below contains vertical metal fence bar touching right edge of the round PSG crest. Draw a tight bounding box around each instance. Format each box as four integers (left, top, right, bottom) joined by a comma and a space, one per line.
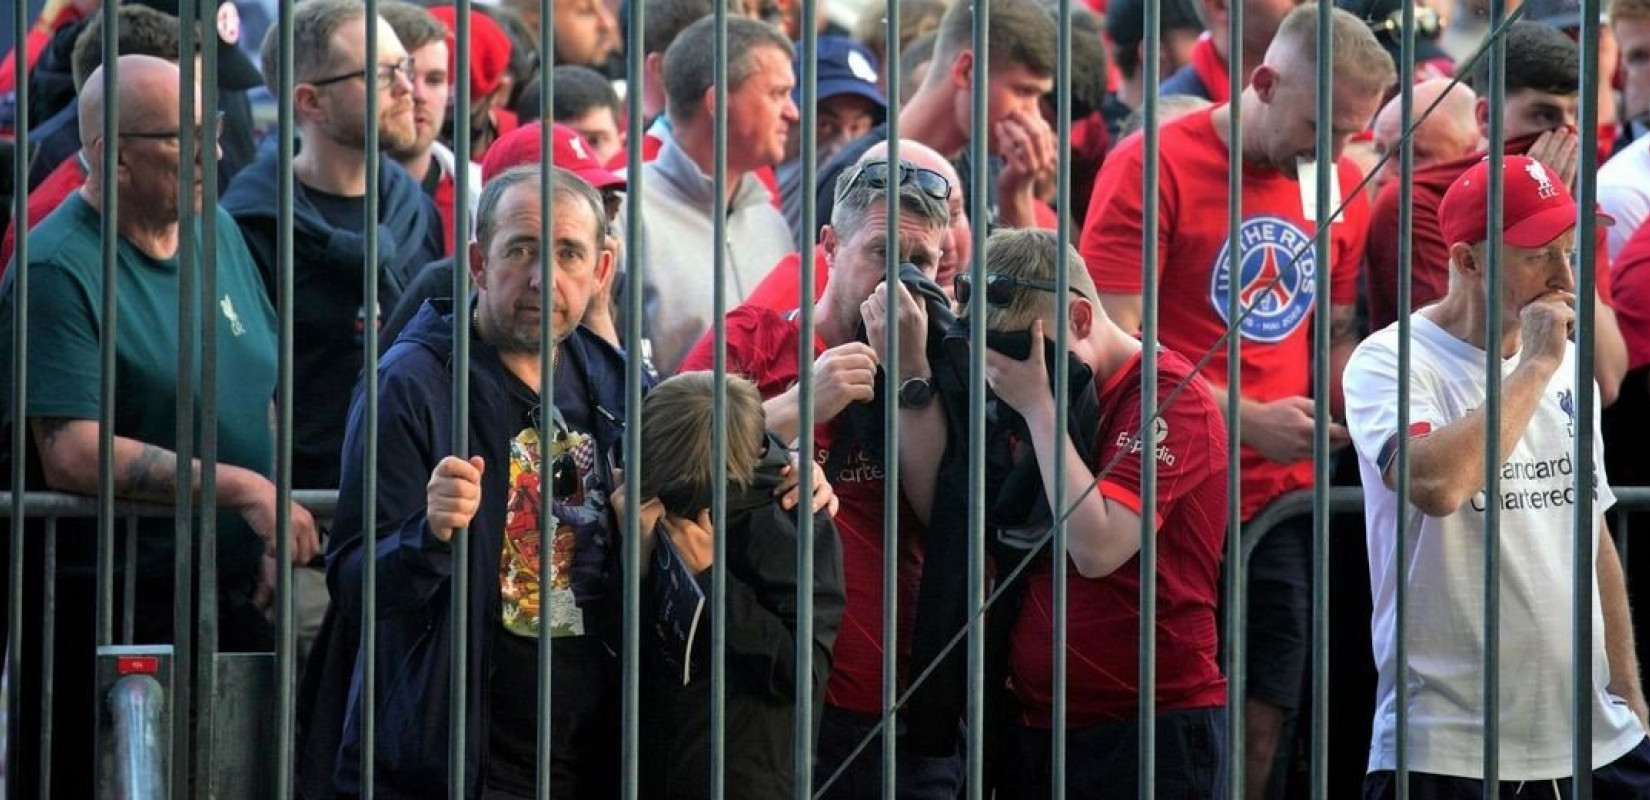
1306, 5, 1338, 800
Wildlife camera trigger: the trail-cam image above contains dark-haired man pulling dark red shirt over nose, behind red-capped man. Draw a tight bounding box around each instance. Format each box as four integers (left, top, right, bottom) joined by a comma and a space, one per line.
1365, 20, 1627, 406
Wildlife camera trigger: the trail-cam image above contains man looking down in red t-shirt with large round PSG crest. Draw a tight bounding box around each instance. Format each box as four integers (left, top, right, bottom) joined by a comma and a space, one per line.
1081, 5, 1396, 797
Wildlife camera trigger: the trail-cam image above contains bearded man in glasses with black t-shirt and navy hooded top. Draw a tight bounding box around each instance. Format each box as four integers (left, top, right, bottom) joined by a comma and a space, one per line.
223, 0, 444, 498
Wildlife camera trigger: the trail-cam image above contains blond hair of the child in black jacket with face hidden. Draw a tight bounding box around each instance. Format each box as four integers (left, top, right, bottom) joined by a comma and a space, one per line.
642, 373, 767, 511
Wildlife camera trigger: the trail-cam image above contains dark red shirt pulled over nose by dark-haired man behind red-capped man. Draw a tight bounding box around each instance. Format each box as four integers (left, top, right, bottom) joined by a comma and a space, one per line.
1365, 135, 1610, 330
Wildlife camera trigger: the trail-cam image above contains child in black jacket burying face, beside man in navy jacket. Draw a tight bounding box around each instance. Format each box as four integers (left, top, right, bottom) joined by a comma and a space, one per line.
640, 373, 845, 798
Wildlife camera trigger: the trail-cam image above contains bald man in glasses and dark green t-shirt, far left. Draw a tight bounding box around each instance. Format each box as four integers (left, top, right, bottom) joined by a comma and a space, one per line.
0, 56, 317, 797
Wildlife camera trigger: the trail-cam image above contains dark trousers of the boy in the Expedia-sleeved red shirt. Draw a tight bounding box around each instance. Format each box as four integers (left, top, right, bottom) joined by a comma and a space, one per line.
997, 708, 1226, 800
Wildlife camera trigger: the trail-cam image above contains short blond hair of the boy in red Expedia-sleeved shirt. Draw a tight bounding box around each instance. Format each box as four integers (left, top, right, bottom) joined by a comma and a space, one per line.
964, 228, 1101, 329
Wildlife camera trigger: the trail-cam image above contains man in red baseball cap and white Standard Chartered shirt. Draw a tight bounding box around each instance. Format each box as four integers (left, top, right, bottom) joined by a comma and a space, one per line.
1343, 155, 1650, 798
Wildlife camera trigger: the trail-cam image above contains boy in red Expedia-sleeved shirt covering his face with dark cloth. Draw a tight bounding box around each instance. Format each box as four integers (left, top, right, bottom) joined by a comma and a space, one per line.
959, 229, 1226, 797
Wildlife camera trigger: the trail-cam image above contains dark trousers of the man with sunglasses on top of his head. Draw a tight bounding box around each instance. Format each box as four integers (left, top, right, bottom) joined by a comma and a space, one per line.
813, 706, 962, 800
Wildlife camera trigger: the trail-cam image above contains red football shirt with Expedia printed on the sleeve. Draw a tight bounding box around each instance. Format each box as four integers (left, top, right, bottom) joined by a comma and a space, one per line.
1010, 350, 1226, 727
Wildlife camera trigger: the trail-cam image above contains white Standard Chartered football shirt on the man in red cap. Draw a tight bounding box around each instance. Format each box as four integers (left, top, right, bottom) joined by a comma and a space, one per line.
1345, 313, 1645, 780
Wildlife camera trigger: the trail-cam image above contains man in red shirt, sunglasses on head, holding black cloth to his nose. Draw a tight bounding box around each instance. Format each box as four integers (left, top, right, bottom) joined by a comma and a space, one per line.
681, 162, 962, 798
